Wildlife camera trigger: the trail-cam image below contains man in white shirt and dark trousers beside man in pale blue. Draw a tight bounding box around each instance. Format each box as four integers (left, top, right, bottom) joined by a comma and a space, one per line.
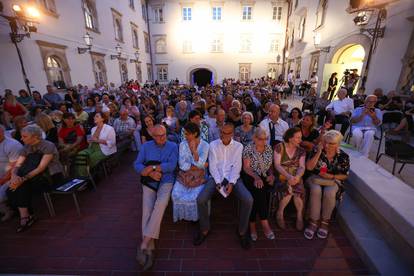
326, 88, 354, 136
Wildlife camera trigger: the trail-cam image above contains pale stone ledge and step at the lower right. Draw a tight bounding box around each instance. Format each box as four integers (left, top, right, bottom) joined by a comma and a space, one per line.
339, 148, 414, 275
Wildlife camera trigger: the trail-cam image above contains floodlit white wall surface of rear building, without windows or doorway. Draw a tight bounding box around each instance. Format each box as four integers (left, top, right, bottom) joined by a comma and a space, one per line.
149, 0, 287, 82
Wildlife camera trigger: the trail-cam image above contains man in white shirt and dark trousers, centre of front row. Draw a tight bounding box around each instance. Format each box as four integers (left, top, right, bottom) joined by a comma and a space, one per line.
193, 124, 253, 249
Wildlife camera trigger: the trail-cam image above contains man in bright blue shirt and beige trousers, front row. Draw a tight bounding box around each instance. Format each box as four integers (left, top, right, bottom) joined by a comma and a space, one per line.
135, 125, 178, 270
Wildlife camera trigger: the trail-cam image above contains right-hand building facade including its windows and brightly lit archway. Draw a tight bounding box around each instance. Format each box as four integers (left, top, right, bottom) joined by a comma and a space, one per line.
285, 0, 414, 94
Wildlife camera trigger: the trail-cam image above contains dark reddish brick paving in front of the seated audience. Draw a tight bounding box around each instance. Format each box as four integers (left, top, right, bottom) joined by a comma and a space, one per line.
0, 153, 369, 275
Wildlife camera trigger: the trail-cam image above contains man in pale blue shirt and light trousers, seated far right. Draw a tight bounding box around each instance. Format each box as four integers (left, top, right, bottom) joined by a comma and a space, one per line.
351, 95, 382, 157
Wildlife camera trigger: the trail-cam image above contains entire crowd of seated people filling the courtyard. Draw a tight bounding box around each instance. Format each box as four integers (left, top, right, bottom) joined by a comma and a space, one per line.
0, 77, 414, 266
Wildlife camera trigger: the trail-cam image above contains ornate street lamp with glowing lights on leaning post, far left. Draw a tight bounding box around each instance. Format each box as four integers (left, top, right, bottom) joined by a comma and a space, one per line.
0, 2, 40, 95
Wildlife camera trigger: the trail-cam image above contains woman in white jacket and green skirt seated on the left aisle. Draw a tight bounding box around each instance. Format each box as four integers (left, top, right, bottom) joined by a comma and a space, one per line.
76, 112, 116, 176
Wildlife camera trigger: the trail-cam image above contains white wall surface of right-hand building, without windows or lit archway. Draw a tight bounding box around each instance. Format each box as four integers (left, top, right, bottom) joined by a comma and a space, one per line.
289, 0, 414, 94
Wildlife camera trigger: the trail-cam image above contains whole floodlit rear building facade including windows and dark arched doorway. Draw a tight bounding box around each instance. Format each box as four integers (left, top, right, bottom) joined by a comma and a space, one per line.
149, 0, 287, 85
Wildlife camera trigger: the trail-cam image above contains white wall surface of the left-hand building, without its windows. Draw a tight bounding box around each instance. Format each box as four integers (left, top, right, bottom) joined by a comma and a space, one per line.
0, 0, 151, 93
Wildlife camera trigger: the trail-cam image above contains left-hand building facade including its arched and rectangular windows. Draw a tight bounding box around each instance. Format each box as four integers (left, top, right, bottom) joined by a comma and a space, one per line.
0, 0, 152, 93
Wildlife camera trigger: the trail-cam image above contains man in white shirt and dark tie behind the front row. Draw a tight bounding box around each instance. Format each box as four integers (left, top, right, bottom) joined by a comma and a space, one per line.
259, 104, 289, 147
